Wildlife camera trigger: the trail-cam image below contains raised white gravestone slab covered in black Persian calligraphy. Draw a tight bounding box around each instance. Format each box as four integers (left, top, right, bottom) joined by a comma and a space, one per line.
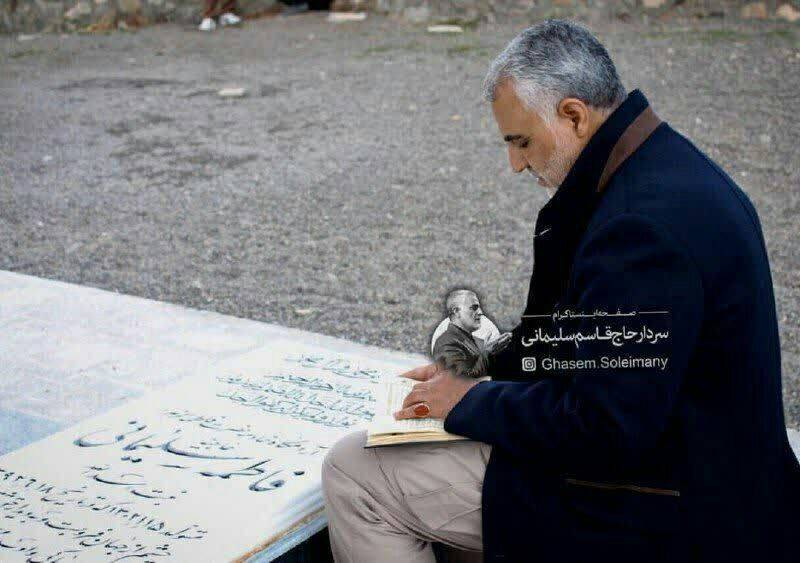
0, 340, 410, 562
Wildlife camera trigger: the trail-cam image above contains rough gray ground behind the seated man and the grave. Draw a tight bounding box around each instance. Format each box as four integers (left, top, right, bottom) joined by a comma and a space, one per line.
0, 13, 800, 427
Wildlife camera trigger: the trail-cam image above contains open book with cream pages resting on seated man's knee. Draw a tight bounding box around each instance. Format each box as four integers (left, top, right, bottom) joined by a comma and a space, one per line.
366, 376, 467, 448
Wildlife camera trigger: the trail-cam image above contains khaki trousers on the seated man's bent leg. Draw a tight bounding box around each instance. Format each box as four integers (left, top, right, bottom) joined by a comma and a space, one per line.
322, 431, 491, 563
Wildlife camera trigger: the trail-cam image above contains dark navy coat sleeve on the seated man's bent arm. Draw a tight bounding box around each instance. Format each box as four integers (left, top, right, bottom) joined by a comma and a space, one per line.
444, 214, 704, 466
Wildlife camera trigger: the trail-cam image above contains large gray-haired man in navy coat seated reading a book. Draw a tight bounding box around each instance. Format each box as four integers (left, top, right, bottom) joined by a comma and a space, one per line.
322, 20, 800, 563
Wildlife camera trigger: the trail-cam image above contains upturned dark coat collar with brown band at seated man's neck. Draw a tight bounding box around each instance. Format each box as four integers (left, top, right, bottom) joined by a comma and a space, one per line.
537, 90, 660, 232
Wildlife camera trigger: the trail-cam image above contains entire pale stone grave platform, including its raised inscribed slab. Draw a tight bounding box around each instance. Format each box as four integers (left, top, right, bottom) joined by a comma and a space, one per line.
0, 271, 800, 563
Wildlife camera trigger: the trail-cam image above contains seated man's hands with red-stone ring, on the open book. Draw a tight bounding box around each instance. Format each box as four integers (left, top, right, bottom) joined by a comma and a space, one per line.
394, 363, 479, 420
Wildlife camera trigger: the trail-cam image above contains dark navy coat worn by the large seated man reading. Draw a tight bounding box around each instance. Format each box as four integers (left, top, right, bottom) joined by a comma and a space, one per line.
445, 91, 800, 563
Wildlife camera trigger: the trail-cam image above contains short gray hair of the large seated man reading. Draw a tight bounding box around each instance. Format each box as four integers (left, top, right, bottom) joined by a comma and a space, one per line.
483, 20, 626, 122
